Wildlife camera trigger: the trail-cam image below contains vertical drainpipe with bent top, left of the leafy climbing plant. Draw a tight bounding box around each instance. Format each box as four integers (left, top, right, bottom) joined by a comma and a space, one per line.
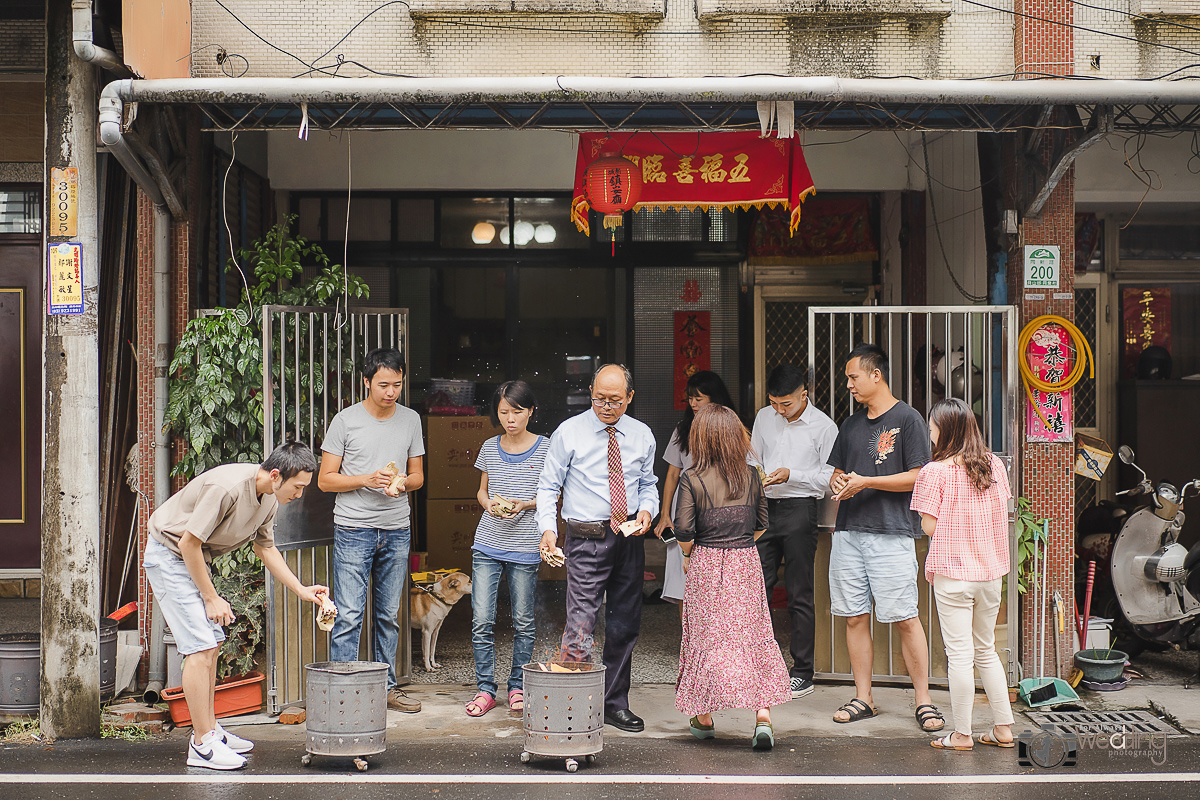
100, 82, 170, 703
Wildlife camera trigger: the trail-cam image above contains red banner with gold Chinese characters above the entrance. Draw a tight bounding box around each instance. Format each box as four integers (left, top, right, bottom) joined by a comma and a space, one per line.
571, 131, 816, 234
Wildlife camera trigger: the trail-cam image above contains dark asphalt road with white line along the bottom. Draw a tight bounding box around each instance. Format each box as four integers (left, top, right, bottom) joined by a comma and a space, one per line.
0, 735, 1200, 800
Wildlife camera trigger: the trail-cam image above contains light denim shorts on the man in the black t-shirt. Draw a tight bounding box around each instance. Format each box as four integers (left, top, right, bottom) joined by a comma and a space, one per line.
829, 530, 918, 625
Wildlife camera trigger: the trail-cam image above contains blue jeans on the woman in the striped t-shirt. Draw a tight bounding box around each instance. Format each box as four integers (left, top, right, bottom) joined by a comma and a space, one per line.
470, 551, 539, 697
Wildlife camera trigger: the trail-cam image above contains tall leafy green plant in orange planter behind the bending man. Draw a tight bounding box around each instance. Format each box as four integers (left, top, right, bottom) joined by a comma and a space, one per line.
163, 217, 368, 724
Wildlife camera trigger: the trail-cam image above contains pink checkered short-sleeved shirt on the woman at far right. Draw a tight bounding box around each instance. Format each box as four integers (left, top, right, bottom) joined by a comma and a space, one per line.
910, 453, 1012, 583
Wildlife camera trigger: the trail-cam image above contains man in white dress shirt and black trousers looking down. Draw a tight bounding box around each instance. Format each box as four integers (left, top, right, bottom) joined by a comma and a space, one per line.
751, 363, 838, 698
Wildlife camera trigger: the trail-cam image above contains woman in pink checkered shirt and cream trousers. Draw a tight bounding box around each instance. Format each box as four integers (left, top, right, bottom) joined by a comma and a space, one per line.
911, 398, 1013, 751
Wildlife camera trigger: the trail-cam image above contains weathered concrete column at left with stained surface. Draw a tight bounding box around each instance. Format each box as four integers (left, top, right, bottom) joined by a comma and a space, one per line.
41, 0, 100, 739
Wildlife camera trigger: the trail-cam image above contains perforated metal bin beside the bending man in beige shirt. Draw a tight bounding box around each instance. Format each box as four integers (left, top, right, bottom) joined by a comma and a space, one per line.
300, 661, 388, 771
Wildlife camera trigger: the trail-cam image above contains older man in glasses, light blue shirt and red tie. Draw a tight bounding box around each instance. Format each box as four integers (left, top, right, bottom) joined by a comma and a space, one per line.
538, 365, 659, 733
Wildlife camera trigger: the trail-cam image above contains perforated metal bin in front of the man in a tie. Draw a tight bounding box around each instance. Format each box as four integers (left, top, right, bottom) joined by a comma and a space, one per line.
521, 662, 605, 772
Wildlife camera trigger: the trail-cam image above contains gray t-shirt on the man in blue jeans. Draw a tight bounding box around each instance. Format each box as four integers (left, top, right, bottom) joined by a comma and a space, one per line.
320, 403, 425, 530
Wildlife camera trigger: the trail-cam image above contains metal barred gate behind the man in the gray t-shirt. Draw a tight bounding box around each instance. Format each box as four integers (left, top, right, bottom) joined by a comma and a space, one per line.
262, 306, 412, 714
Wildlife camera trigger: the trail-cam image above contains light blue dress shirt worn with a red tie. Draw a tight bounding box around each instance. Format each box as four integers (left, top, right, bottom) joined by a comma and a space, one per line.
538, 409, 659, 531
